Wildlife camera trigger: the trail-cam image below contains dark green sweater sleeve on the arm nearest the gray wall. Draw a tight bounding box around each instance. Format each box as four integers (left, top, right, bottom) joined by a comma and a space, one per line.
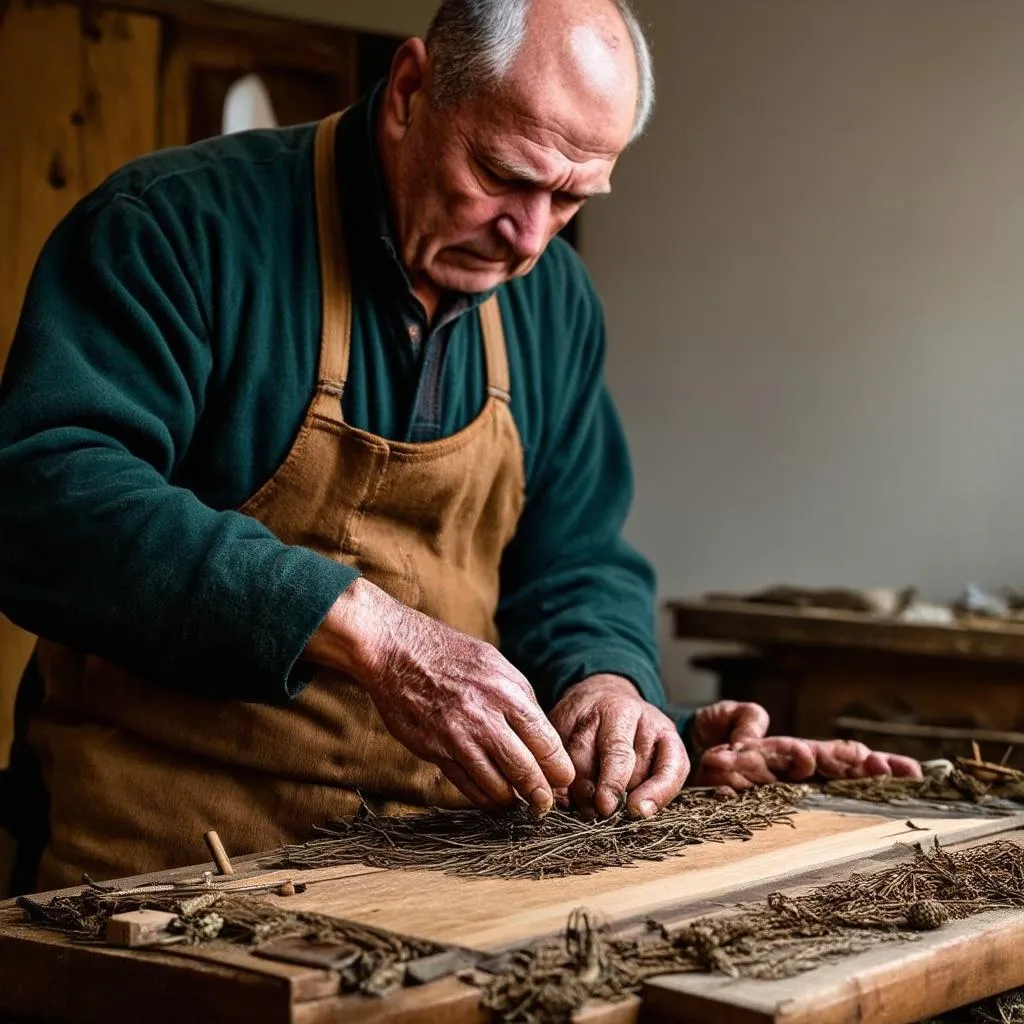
498, 257, 665, 708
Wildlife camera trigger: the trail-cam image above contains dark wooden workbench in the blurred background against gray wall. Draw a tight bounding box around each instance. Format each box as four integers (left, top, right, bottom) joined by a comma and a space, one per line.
668, 600, 1024, 767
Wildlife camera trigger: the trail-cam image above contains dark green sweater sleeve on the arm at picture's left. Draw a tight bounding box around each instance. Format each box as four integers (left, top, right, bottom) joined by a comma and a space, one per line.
0, 195, 357, 701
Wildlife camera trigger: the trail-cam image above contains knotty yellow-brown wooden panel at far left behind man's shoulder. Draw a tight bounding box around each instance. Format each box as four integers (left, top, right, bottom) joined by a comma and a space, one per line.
0, 0, 161, 766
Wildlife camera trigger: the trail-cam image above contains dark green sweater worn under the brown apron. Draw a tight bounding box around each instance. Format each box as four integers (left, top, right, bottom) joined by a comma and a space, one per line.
0, 86, 663, 706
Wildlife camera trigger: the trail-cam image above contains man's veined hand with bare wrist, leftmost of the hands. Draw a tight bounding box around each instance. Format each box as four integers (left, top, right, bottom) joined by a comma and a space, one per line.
306, 580, 573, 813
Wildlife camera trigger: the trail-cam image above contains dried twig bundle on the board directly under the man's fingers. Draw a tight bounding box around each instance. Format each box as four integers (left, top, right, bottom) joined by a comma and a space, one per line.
282, 784, 806, 879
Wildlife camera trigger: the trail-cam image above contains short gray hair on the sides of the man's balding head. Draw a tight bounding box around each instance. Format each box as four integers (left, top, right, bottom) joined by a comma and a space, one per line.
427, 0, 654, 142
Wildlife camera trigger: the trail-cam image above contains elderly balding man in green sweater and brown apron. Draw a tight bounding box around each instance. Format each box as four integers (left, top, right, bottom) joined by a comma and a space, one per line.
0, 0, 913, 886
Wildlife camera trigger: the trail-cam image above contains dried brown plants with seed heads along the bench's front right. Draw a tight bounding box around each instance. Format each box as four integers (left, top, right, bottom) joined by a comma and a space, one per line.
482, 841, 1024, 1024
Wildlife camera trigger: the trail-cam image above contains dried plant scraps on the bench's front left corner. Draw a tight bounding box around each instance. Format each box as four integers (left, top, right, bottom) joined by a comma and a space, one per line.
17, 886, 443, 995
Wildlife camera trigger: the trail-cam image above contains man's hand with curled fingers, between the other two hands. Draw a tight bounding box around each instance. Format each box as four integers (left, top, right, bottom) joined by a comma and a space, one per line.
551, 675, 690, 818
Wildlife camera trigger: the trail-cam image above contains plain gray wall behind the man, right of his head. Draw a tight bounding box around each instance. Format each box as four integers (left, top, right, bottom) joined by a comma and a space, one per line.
582, 0, 1024, 696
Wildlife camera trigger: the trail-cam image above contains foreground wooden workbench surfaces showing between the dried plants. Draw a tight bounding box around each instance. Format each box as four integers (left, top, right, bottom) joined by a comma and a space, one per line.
0, 805, 1024, 1024
